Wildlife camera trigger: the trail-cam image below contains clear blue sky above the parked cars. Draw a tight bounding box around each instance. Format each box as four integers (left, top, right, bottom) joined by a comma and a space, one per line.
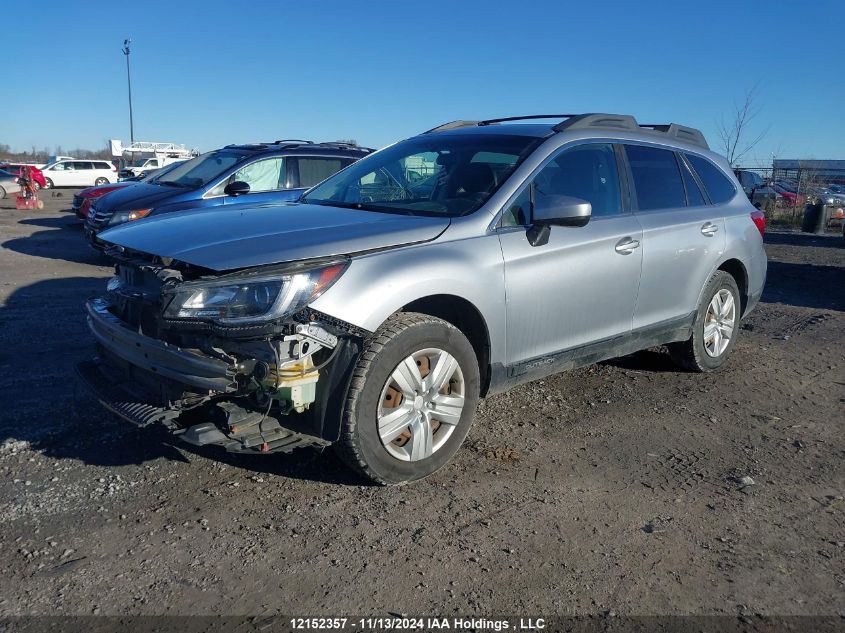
0, 0, 845, 162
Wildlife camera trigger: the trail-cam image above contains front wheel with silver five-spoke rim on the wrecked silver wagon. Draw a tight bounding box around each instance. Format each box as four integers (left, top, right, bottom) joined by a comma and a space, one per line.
336, 312, 480, 485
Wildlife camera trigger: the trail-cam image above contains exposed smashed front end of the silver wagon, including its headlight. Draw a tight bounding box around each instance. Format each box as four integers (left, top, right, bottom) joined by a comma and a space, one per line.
79, 250, 366, 453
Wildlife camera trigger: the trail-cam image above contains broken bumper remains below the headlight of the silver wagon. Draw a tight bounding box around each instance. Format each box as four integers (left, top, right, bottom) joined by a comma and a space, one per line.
78, 299, 360, 453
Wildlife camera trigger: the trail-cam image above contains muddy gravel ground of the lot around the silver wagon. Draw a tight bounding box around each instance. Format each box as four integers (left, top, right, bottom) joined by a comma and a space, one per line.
0, 190, 845, 616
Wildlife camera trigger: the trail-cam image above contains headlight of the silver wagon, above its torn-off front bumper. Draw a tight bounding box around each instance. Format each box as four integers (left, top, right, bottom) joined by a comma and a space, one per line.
164, 262, 347, 324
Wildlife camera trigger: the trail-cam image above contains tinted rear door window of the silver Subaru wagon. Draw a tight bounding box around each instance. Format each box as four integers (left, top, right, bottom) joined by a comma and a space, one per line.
625, 145, 687, 211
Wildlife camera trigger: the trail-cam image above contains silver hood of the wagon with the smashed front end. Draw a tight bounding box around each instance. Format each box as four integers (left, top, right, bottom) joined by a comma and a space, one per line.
99, 200, 449, 271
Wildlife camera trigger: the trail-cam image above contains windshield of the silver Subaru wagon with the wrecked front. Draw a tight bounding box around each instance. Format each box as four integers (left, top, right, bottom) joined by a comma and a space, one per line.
302, 134, 543, 217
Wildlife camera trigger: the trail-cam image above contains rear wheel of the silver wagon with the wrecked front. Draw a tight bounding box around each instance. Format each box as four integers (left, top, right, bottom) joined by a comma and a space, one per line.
667, 270, 742, 372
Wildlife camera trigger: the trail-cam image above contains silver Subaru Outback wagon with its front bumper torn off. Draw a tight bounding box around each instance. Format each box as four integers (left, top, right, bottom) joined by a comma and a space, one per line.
79, 114, 766, 484
